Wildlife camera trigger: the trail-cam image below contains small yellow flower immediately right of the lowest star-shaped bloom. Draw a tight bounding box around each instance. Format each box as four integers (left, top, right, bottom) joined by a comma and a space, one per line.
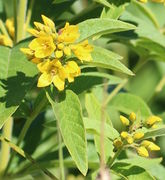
65, 61, 81, 82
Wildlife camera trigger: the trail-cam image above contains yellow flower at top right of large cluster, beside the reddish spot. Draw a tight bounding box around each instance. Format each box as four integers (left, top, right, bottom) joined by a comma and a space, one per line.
58, 22, 80, 43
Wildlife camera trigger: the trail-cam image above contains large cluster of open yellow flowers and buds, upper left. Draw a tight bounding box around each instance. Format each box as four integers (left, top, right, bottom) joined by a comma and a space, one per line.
21, 15, 93, 91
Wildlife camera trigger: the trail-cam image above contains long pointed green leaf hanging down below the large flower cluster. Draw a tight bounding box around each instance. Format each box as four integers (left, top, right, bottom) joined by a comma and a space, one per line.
47, 90, 88, 175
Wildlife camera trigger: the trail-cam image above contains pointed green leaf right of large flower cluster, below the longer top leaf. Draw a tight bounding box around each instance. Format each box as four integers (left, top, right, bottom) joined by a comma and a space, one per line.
88, 46, 134, 75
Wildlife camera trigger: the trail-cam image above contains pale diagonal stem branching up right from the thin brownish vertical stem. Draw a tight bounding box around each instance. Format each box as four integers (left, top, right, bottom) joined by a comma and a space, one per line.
104, 79, 128, 106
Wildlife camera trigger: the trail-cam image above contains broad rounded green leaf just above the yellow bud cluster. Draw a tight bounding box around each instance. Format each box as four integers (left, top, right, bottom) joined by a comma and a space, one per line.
110, 93, 151, 118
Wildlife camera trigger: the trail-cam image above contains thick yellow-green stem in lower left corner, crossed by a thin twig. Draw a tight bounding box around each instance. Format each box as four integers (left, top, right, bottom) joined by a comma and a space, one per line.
0, 117, 13, 177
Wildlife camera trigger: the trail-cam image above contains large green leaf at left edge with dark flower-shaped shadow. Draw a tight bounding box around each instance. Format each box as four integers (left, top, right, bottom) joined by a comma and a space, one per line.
0, 42, 37, 128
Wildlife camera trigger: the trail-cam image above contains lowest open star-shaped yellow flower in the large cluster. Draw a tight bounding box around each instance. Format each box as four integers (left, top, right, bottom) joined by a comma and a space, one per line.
37, 59, 66, 91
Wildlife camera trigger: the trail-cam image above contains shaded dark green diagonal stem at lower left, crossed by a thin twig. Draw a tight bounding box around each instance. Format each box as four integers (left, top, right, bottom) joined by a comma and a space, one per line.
5, 96, 47, 174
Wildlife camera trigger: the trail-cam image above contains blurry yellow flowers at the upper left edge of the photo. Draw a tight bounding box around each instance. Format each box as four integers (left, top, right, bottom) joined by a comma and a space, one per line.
0, 18, 15, 47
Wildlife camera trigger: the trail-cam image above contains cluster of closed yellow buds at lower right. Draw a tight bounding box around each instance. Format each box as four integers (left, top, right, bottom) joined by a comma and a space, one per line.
113, 112, 161, 157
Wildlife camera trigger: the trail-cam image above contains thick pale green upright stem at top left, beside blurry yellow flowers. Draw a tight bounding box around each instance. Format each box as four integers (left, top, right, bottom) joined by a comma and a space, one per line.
17, 0, 27, 42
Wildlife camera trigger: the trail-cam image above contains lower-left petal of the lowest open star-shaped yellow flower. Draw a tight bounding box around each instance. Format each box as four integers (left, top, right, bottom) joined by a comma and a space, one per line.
37, 72, 53, 87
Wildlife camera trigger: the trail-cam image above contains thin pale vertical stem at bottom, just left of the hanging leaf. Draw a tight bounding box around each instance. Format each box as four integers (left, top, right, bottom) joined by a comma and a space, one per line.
57, 122, 65, 180
